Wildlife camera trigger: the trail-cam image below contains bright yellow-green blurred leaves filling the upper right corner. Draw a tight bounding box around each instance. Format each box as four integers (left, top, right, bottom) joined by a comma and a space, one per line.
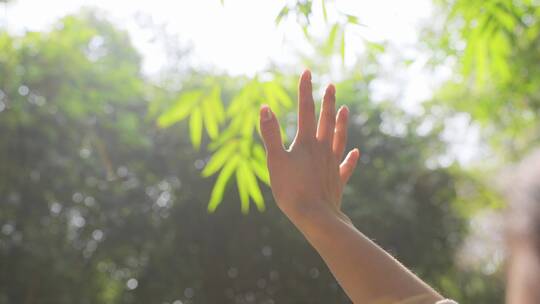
426, 0, 540, 161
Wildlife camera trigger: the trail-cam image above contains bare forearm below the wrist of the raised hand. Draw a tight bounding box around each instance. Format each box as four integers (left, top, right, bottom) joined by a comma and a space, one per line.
291, 208, 442, 304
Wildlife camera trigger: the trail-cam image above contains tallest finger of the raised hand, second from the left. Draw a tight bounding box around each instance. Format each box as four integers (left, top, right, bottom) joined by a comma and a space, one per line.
296, 70, 315, 141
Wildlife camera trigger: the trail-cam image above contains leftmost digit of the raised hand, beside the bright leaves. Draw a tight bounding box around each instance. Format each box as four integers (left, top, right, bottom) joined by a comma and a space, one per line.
260, 105, 285, 158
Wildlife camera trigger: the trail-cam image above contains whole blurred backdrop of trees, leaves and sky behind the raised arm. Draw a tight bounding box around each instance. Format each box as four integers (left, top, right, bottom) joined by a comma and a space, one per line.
0, 0, 540, 304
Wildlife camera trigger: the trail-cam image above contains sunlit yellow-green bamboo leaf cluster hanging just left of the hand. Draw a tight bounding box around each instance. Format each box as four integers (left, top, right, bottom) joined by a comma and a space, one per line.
154, 77, 293, 213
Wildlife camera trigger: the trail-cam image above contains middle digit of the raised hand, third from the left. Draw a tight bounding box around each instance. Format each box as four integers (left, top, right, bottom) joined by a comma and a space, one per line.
317, 84, 336, 145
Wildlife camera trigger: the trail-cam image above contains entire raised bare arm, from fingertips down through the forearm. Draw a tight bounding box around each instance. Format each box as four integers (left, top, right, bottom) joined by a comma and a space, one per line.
260, 71, 443, 304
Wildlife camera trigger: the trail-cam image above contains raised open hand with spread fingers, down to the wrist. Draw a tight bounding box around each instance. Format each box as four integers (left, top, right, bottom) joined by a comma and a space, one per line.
260, 71, 360, 225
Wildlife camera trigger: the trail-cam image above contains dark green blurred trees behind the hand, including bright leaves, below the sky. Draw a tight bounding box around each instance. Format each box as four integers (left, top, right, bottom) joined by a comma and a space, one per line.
0, 8, 502, 304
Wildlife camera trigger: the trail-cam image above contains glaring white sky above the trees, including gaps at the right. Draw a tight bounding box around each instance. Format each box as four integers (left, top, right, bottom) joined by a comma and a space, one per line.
0, 0, 477, 161
